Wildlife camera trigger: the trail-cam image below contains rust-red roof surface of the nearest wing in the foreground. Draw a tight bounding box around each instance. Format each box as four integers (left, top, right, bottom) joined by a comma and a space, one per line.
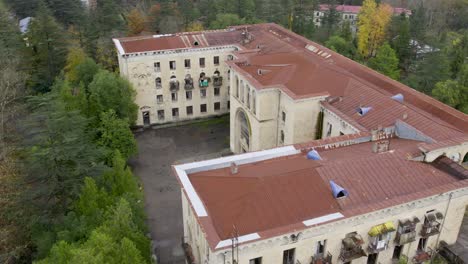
188, 138, 468, 248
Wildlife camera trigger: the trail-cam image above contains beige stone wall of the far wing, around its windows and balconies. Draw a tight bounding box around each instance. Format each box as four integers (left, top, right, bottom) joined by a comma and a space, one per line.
119, 47, 234, 125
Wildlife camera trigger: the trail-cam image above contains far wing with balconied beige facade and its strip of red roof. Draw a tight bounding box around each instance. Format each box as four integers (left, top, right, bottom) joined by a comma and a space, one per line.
114, 36, 237, 126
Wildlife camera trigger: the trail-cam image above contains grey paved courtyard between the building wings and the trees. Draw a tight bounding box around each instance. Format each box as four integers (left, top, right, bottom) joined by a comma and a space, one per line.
130, 116, 229, 264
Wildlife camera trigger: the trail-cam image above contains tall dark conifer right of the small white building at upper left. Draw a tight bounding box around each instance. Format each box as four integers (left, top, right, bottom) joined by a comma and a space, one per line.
27, 2, 67, 92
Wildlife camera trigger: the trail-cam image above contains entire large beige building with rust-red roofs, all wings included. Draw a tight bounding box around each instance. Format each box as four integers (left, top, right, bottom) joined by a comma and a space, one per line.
115, 24, 468, 264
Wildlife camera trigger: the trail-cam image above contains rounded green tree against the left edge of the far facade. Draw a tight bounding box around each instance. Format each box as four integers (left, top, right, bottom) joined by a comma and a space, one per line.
89, 70, 138, 124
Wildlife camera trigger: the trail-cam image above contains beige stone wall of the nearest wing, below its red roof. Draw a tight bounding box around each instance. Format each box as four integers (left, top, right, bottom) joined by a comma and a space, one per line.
204, 190, 468, 264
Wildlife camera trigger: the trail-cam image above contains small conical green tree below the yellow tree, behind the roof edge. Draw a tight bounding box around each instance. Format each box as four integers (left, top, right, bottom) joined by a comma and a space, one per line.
368, 43, 400, 80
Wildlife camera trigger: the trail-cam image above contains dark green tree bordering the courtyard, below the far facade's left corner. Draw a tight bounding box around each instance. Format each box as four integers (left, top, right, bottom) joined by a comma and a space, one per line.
97, 110, 137, 160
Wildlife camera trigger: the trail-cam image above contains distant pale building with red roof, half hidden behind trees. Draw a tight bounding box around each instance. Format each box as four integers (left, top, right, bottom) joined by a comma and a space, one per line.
313, 4, 411, 32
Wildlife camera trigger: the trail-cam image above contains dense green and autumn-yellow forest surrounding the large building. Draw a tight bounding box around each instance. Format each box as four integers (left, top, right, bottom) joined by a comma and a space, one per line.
0, 0, 468, 263
